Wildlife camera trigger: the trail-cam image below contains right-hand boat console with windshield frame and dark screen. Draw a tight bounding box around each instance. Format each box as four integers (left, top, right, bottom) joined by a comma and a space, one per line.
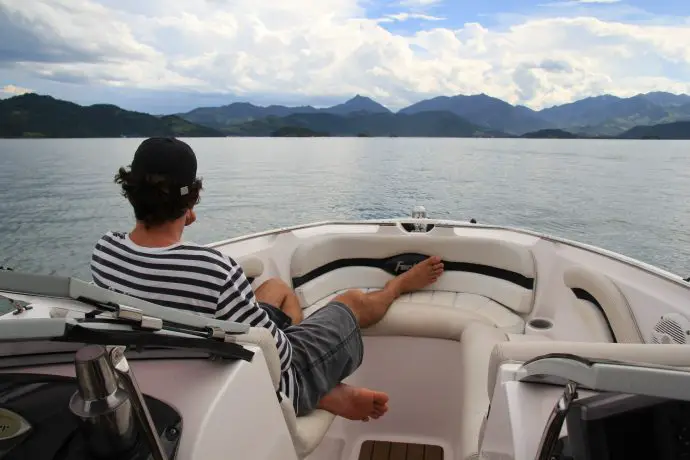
510, 354, 690, 460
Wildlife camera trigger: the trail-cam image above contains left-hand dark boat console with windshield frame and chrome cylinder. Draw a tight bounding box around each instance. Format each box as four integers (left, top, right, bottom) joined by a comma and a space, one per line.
0, 275, 253, 460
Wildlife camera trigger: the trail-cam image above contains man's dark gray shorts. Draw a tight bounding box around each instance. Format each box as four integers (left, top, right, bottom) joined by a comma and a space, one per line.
284, 302, 364, 416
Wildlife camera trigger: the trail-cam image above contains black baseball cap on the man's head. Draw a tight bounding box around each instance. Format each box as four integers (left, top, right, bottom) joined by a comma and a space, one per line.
131, 137, 197, 195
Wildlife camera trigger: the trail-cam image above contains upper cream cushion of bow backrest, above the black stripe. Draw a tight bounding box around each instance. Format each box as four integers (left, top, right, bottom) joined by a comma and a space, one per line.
290, 234, 536, 277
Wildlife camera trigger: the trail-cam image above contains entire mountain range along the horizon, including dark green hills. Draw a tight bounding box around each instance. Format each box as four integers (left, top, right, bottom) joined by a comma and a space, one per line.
0, 92, 690, 139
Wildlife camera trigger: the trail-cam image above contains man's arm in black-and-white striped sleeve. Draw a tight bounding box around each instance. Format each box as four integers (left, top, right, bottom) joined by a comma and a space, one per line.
216, 261, 292, 372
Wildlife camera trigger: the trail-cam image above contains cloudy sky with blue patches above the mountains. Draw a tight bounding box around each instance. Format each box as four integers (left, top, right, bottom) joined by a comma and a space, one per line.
0, 0, 690, 114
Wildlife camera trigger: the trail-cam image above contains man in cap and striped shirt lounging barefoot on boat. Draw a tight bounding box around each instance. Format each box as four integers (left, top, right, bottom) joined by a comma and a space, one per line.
91, 138, 443, 421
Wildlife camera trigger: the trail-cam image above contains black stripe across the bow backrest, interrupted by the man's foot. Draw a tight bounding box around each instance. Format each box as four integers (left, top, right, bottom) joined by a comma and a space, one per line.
292, 253, 534, 290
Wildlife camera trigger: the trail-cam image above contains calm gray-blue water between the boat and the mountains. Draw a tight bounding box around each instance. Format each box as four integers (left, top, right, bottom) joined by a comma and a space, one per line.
0, 139, 690, 279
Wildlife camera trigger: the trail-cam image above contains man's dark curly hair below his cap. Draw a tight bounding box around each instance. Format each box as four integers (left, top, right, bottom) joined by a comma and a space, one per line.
115, 168, 203, 228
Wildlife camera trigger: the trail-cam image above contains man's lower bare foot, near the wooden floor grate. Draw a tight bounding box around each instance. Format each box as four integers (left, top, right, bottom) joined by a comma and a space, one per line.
318, 383, 388, 422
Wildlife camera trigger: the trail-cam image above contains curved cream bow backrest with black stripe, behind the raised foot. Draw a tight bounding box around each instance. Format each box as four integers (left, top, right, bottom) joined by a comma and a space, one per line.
290, 234, 537, 314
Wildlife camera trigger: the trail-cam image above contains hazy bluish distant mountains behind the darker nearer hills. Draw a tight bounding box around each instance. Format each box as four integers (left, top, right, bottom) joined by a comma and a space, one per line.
177, 92, 690, 137
